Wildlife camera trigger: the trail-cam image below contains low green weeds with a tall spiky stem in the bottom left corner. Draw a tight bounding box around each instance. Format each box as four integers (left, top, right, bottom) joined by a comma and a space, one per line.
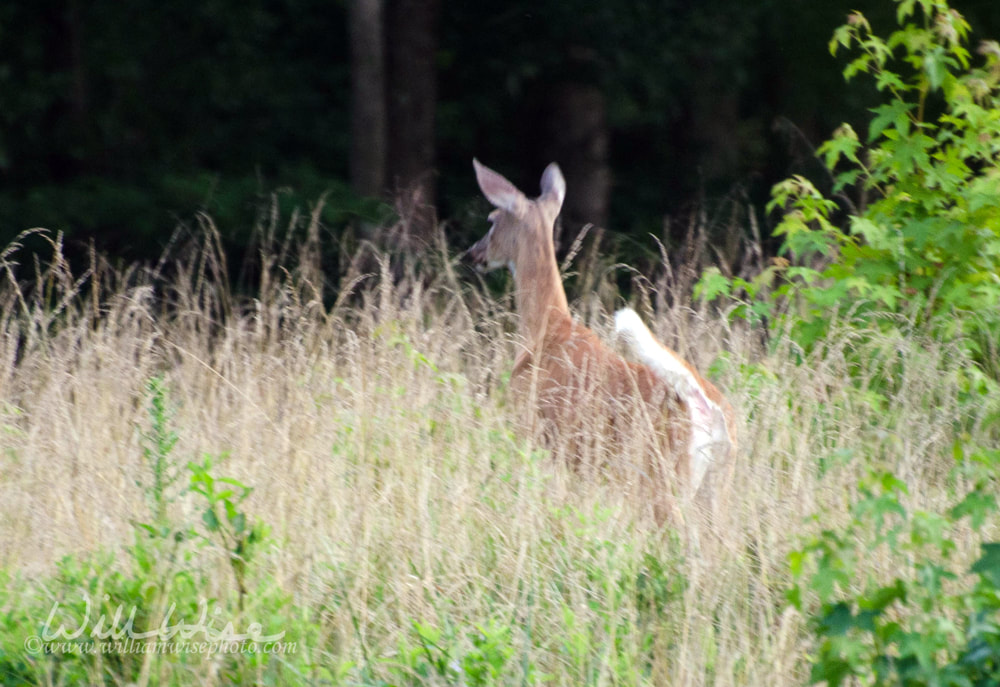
0, 377, 290, 684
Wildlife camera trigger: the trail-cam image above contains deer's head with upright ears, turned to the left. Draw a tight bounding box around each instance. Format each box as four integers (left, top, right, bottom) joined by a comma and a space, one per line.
466, 160, 566, 274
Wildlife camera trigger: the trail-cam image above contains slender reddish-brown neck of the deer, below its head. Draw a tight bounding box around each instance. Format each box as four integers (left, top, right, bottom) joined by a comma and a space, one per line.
514, 244, 572, 350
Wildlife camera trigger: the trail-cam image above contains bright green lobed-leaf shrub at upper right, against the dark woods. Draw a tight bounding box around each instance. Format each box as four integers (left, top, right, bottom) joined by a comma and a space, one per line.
700, 0, 1000, 377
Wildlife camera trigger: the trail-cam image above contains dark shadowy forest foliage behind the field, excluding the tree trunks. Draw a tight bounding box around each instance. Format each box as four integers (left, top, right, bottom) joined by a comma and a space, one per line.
0, 0, 997, 266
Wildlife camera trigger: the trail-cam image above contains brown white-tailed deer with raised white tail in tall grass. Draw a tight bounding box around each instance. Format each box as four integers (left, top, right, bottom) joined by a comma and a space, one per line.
464, 159, 736, 520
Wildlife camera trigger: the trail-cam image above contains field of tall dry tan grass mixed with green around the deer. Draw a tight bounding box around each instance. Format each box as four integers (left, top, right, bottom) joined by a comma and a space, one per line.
0, 218, 997, 686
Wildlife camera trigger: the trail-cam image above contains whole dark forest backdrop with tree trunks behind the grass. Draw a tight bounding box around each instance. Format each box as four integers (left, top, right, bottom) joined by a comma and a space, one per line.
0, 0, 1000, 276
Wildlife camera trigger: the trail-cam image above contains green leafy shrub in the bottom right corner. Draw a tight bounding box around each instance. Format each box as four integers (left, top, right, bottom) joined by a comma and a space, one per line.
789, 451, 1000, 687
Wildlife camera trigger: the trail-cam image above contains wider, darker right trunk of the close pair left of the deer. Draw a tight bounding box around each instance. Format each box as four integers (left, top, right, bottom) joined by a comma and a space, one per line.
387, 0, 440, 244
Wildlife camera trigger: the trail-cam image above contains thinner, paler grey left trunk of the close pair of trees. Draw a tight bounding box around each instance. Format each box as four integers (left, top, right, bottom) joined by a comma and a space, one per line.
348, 0, 388, 196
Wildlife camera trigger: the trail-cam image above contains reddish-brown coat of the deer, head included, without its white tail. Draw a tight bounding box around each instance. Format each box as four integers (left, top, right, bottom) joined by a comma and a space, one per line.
467, 162, 731, 520
